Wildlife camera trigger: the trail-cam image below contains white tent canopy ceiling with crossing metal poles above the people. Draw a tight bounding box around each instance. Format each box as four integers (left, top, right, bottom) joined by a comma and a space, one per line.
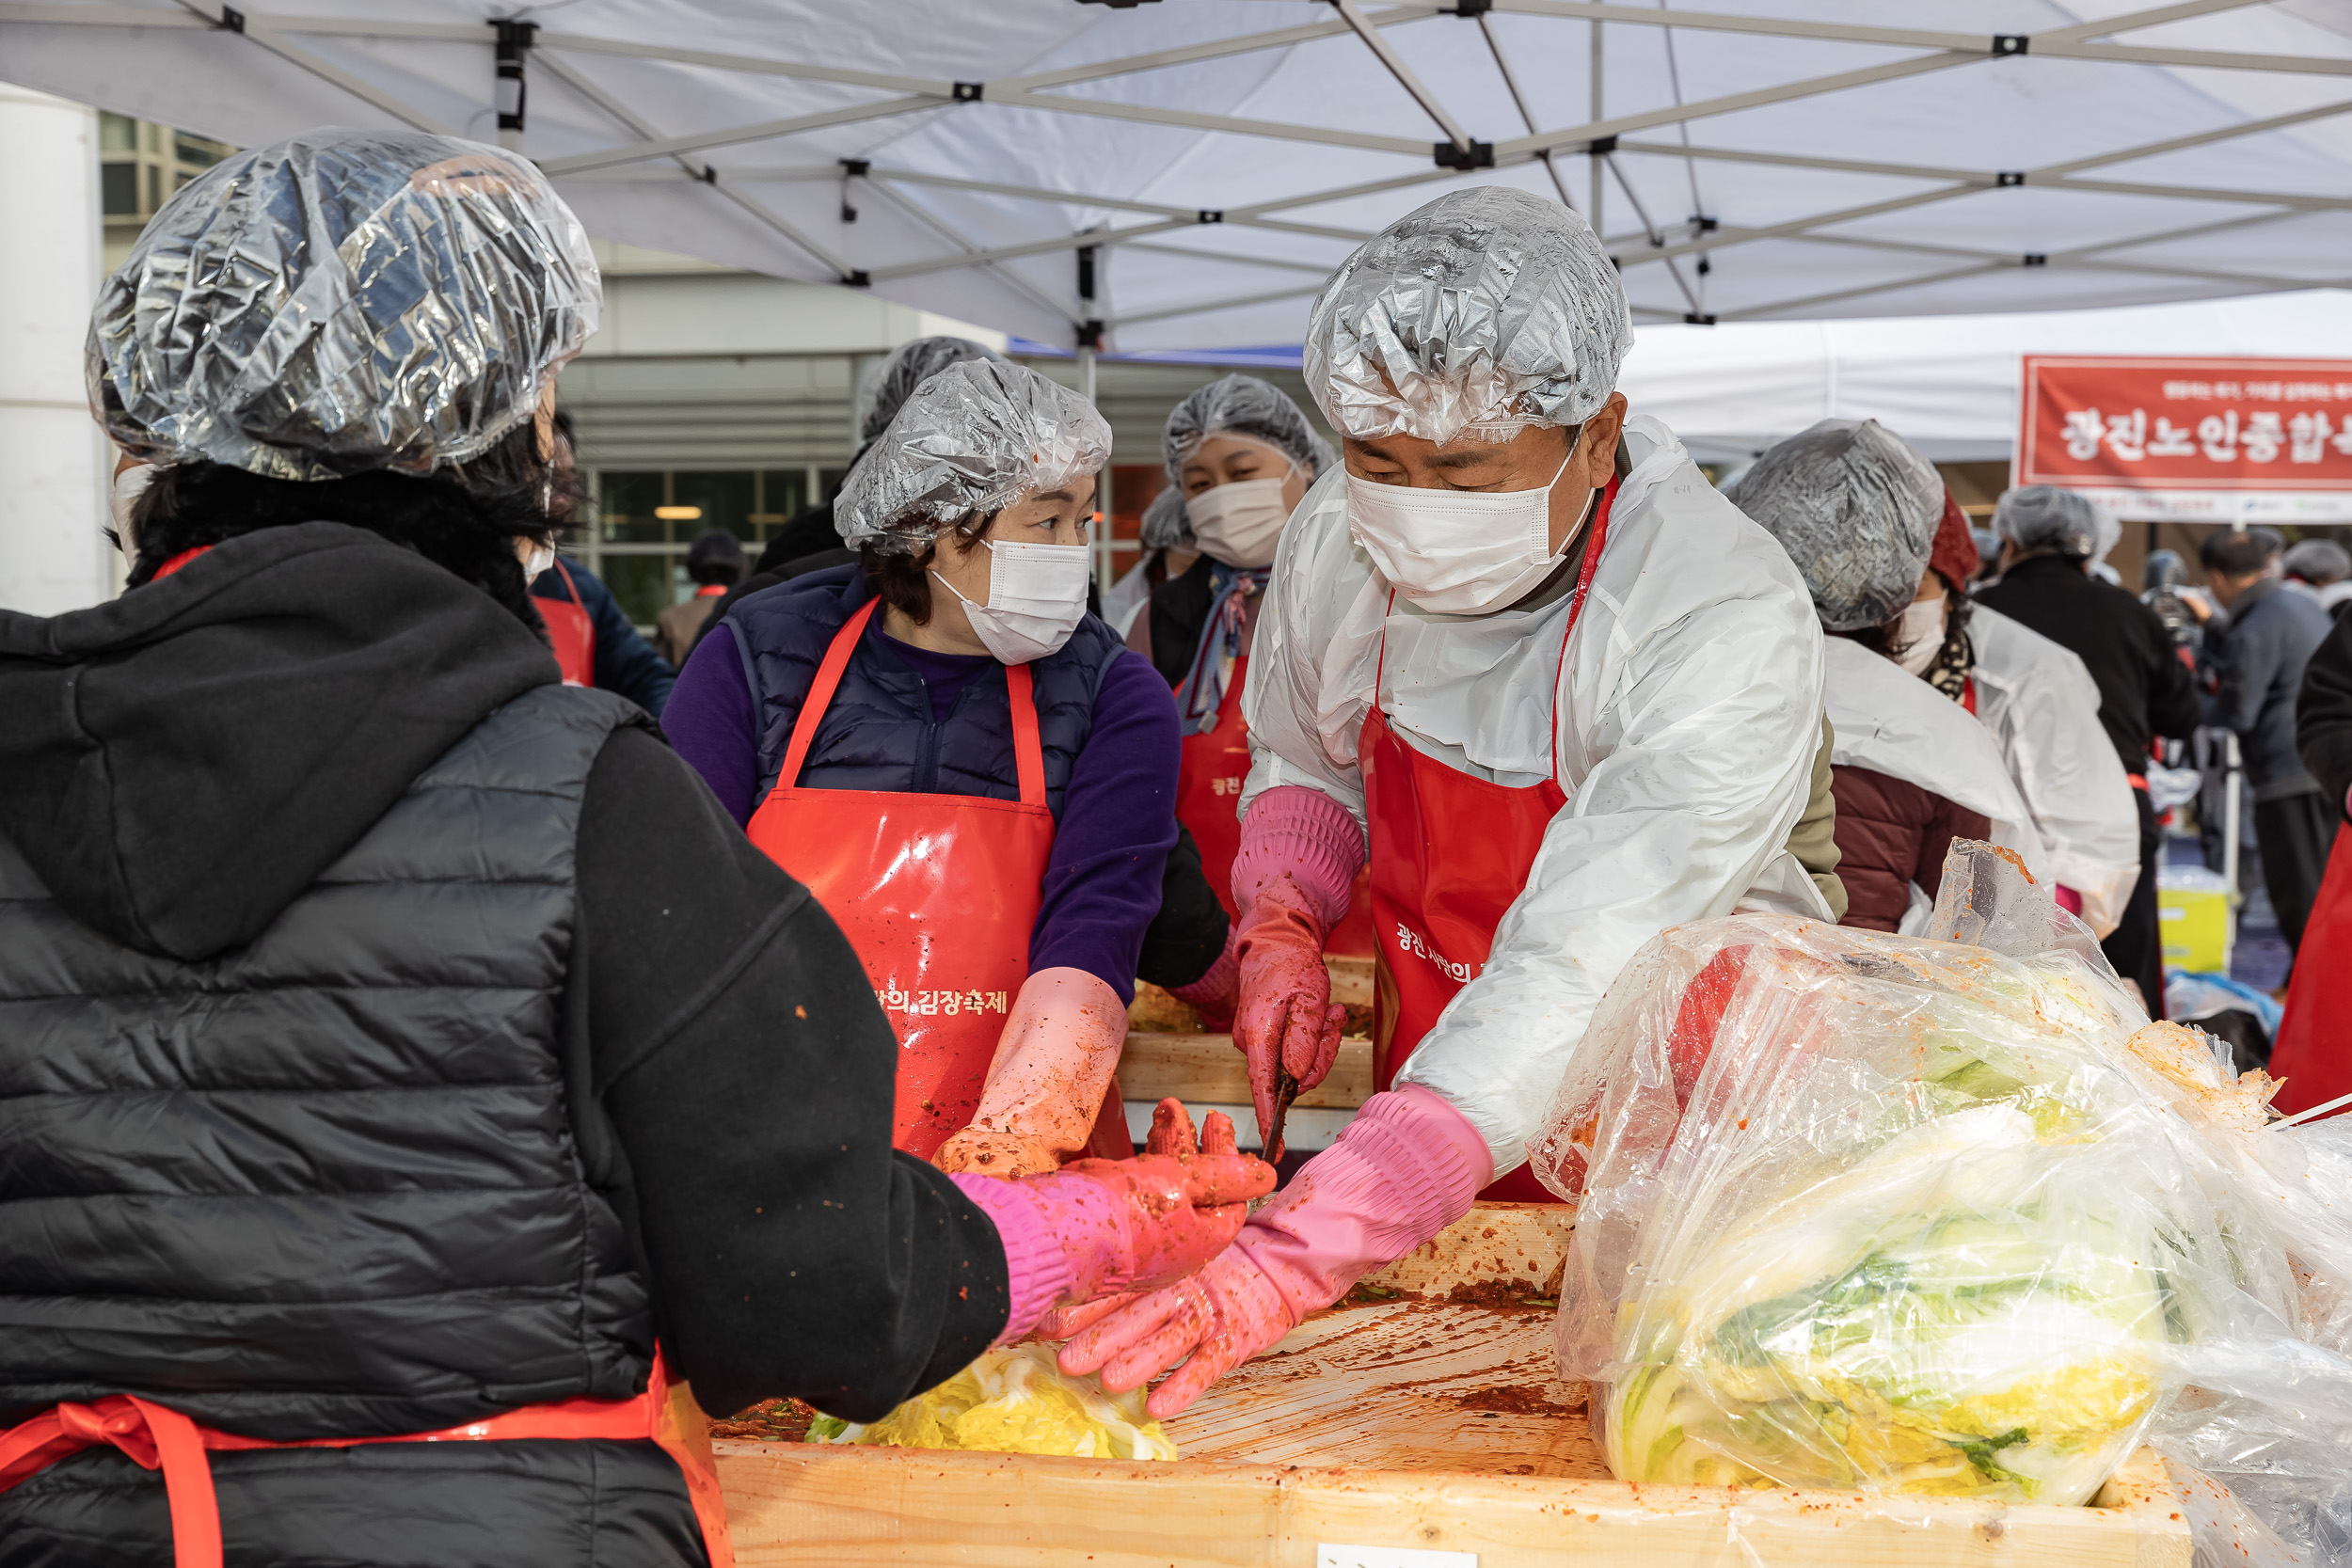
13, 0, 2352, 350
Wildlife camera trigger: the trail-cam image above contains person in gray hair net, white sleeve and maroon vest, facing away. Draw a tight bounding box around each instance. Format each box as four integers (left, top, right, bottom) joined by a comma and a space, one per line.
1729, 419, 2044, 931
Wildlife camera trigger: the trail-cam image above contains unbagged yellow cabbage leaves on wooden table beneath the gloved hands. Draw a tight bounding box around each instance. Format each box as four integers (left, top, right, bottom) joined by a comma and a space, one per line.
809, 1345, 1176, 1460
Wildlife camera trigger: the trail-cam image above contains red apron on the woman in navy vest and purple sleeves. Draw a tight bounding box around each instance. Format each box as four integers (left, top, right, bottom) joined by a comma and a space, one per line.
748, 599, 1063, 1159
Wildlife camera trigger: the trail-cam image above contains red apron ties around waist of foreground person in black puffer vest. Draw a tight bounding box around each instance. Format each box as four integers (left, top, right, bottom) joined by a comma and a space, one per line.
0, 1347, 734, 1568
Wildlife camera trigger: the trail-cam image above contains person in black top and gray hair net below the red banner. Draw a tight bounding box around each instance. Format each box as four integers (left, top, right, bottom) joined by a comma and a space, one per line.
1976, 484, 2200, 1016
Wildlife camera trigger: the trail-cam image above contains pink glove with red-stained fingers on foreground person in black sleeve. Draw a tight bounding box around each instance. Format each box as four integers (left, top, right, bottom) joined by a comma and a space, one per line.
953, 1101, 1275, 1345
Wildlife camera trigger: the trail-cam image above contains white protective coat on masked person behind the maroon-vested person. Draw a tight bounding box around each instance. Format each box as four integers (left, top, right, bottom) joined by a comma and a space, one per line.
1969, 604, 2140, 941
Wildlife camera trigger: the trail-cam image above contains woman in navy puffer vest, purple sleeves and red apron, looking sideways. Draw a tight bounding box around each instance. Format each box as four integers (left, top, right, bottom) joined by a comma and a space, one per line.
666, 359, 1179, 1176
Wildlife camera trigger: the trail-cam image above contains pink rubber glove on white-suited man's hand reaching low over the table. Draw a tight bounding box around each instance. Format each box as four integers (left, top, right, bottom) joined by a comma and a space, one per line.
1044, 1084, 1494, 1420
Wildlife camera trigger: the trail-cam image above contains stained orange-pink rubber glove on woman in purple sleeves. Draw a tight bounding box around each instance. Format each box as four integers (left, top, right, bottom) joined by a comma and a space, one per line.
931, 969, 1127, 1176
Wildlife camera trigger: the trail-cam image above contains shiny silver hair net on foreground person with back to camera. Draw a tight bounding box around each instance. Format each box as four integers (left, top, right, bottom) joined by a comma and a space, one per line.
87, 132, 602, 480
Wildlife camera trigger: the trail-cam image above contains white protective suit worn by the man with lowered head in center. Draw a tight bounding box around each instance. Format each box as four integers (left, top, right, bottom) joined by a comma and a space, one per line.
1242, 416, 1825, 1176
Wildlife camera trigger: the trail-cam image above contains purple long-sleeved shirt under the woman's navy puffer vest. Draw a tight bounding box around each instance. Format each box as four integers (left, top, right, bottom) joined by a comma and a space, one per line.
661, 610, 1184, 1002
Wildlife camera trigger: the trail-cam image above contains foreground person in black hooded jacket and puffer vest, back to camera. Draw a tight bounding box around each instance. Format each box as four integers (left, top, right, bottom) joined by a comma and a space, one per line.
0, 132, 1273, 1568
